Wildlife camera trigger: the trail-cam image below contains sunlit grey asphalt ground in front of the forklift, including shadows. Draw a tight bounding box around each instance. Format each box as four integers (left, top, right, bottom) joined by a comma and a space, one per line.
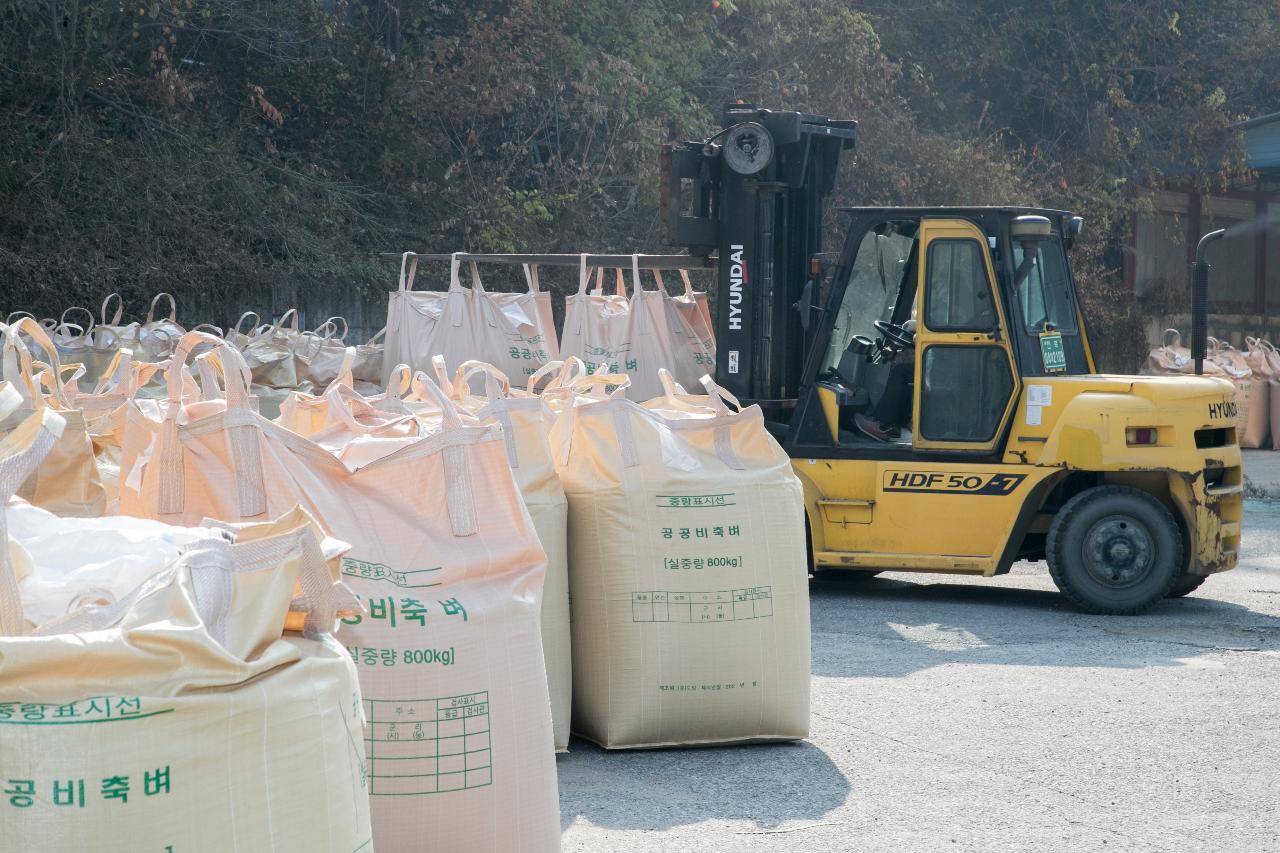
559, 502, 1280, 853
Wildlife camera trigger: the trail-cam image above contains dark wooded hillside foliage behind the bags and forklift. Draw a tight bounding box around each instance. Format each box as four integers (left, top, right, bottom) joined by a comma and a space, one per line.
0, 0, 1280, 358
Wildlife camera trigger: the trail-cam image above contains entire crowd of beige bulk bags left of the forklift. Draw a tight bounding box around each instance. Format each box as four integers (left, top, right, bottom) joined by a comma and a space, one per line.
0, 249, 809, 853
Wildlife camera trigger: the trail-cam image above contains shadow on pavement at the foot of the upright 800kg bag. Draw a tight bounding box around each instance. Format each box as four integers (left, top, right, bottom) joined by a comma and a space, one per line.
557, 738, 850, 830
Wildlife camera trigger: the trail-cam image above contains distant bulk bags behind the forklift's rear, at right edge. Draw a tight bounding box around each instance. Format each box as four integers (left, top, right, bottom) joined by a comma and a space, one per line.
1142, 329, 1280, 448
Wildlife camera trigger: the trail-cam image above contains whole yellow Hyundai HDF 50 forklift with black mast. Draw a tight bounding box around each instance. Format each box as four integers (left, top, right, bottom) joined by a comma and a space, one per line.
663, 105, 1243, 613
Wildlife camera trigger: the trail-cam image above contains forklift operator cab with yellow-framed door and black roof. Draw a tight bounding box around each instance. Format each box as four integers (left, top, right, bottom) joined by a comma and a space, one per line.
786, 207, 1093, 456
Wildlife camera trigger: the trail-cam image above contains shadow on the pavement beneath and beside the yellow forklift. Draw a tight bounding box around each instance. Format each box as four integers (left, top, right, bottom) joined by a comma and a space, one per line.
810, 563, 1280, 678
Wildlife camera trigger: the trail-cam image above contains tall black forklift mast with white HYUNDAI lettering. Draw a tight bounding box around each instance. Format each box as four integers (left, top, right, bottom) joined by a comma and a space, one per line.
662, 104, 858, 409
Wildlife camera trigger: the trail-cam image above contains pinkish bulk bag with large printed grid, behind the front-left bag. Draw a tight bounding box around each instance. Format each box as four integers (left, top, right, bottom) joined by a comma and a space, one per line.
122, 336, 561, 853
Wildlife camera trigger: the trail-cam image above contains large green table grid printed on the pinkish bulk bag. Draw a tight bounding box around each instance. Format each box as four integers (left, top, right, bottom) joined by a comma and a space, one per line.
365, 690, 493, 797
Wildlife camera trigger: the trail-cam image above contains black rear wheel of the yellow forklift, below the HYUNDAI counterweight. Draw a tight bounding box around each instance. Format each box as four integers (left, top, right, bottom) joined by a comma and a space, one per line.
1044, 485, 1183, 615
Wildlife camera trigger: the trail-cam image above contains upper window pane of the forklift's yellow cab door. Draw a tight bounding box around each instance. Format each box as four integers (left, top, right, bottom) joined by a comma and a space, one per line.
924, 240, 996, 332
